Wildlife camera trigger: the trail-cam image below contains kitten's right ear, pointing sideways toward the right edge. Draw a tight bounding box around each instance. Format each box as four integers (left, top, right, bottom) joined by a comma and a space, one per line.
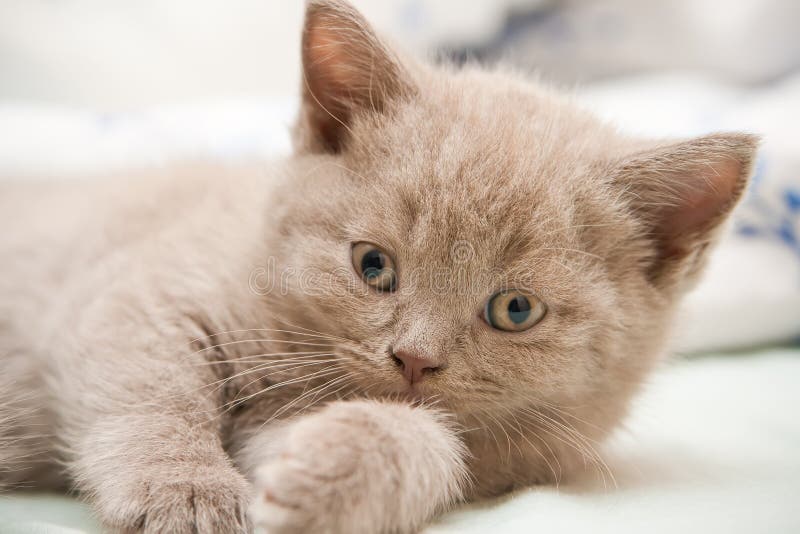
616, 133, 758, 292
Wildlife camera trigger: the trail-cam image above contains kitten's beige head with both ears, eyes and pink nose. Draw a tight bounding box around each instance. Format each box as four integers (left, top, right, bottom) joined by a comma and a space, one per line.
268, 0, 756, 436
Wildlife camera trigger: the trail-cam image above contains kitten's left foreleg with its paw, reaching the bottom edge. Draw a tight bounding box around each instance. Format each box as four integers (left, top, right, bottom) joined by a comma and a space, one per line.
56, 334, 251, 534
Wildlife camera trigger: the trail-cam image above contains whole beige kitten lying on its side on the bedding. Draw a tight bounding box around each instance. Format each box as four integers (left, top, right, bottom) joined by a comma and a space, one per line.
0, 0, 756, 533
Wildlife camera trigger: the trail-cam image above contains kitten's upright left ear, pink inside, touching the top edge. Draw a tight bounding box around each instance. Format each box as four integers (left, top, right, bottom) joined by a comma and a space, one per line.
296, 0, 413, 153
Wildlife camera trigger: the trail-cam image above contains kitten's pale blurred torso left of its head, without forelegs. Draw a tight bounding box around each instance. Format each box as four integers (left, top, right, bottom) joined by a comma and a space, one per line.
0, 170, 269, 482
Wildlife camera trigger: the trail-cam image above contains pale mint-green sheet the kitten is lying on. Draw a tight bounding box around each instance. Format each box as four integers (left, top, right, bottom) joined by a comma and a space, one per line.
0, 349, 800, 534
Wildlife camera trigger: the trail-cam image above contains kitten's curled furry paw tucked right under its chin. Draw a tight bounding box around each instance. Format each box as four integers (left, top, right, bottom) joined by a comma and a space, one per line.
243, 401, 466, 534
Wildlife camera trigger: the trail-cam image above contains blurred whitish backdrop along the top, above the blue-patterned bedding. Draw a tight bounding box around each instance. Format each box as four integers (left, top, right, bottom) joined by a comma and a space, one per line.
0, 0, 800, 105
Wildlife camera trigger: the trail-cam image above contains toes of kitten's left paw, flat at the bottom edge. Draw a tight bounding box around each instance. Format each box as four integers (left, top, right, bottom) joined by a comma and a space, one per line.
96, 467, 253, 534
